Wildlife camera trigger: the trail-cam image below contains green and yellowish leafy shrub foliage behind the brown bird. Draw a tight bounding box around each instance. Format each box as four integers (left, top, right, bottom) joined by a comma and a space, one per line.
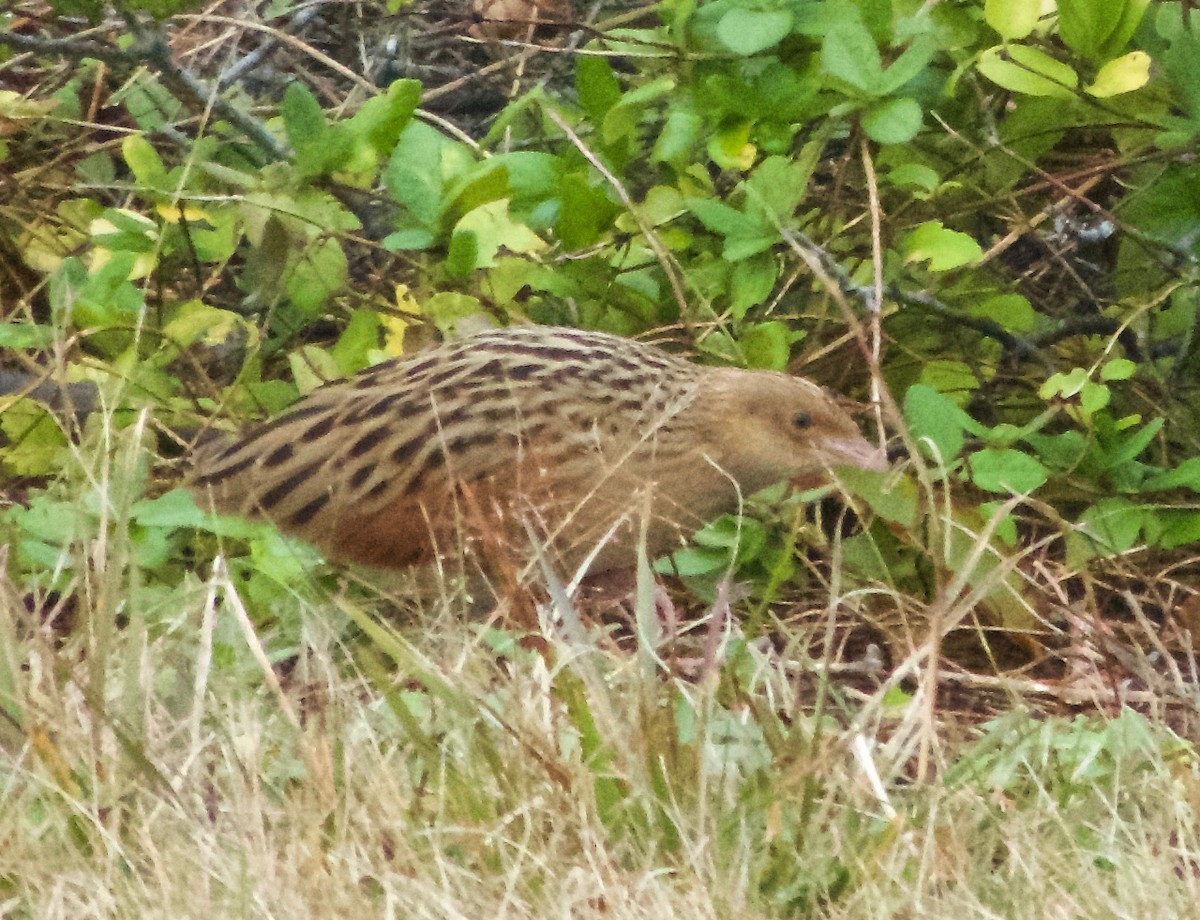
0, 0, 1200, 642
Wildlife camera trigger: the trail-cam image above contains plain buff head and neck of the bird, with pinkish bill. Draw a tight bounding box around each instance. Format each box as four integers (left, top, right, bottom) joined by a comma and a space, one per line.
706, 368, 887, 492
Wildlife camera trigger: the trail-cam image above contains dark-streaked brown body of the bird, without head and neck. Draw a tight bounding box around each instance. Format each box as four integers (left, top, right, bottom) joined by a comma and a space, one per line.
192, 326, 703, 567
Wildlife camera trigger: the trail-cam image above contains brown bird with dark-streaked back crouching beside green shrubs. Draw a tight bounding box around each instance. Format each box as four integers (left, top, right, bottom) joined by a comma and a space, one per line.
191, 326, 884, 575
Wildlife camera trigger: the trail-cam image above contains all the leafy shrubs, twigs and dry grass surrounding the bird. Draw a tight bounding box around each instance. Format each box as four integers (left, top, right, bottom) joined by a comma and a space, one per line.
0, 0, 1200, 918
